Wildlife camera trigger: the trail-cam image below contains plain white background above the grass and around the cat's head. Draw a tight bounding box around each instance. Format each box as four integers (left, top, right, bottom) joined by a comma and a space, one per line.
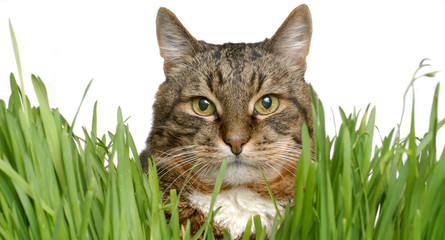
0, 0, 445, 151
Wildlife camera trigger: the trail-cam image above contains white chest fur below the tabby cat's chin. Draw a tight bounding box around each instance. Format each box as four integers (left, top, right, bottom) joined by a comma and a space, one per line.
189, 187, 286, 239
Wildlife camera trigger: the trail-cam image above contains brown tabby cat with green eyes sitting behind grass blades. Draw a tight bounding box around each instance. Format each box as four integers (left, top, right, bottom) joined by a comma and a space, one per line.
140, 5, 313, 239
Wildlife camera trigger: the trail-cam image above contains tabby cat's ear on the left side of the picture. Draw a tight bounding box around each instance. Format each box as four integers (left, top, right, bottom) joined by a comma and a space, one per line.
156, 8, 201, 70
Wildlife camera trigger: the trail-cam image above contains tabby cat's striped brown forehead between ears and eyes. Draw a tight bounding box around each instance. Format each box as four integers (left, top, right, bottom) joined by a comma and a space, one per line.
170, 42, 298, 101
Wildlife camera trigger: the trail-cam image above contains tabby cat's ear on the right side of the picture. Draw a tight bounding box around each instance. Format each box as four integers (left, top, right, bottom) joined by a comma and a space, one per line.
265, 5, 312, 65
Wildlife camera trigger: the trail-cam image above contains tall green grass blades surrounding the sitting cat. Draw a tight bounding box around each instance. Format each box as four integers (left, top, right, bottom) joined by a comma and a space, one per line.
0, 23, 445, 239
